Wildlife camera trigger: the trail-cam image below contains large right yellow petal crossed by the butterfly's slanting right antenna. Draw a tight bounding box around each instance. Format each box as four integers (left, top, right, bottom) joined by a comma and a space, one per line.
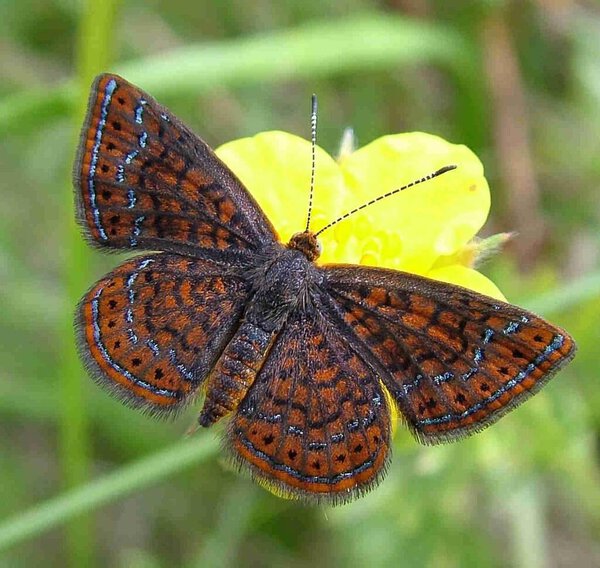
335, 132, 490, 274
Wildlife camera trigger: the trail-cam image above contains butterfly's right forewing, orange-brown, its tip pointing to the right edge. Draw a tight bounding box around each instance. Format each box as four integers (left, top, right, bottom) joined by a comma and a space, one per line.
327, 266, 575, 443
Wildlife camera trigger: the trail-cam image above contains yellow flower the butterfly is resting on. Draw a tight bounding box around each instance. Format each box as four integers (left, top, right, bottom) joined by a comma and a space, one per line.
217, 131, 504, 299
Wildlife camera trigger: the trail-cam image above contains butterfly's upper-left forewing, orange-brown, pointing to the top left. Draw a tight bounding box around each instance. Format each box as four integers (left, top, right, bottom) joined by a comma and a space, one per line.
74, 75, 275, 258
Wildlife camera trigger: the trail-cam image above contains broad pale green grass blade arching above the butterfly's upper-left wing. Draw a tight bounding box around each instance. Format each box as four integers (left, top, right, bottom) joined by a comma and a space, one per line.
0, 14, 474, 135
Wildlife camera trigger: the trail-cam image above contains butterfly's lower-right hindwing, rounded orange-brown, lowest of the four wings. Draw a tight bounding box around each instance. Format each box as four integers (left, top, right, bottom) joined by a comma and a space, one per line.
228, 311, 390, 503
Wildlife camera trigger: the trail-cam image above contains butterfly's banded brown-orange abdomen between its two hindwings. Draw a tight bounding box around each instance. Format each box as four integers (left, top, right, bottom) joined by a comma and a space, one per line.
198, 321, 276, 427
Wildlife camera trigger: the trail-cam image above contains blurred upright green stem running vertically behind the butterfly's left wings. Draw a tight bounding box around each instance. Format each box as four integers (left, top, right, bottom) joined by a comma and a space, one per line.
57, 0, 117, 566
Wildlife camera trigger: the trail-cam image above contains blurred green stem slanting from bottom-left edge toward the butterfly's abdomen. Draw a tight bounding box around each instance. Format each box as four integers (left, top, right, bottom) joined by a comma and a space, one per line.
0, 434, 219, 551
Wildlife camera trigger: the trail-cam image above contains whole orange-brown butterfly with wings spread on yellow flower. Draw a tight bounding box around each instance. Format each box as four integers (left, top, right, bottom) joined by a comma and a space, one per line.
74, 74, 575, 504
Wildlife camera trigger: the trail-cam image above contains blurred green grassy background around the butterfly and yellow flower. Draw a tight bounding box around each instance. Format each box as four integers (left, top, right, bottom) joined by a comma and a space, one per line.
0, 0, 600, 568
